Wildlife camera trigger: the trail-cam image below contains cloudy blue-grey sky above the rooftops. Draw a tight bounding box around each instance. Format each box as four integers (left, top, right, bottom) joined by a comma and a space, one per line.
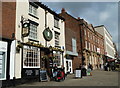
40, 0, 118, 49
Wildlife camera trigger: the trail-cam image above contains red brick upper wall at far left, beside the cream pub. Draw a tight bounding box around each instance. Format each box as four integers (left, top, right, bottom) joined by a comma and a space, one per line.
0, 2, 16, 39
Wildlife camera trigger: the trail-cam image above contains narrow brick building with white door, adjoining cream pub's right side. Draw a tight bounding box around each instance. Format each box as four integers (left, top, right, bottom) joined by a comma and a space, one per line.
60, 8, 82, 73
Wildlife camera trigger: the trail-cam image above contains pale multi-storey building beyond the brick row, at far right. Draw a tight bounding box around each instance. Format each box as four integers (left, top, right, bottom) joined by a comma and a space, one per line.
95, 26, 115, 59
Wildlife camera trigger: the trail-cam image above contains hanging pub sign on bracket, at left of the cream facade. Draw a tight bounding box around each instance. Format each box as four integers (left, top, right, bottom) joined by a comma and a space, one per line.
22, 23, 30, 37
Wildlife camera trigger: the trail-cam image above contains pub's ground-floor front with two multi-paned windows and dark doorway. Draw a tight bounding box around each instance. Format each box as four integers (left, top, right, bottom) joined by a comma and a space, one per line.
21, 42, 64, 81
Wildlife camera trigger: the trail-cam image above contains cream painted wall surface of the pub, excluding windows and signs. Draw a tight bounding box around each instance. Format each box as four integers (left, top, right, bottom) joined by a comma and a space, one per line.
15, 0, 66, 78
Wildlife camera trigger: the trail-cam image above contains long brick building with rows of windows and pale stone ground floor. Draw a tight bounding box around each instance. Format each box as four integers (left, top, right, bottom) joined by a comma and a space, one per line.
80, 19, 104, 69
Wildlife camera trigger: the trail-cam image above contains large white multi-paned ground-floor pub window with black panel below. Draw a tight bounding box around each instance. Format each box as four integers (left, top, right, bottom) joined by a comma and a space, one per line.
22, 45, 40, 80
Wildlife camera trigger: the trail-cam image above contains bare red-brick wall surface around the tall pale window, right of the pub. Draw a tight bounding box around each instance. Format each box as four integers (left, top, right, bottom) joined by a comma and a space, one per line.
60, 9, 82, 71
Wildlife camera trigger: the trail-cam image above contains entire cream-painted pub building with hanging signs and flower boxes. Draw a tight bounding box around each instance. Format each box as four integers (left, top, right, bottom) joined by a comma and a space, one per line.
15, 0, 65, 81
